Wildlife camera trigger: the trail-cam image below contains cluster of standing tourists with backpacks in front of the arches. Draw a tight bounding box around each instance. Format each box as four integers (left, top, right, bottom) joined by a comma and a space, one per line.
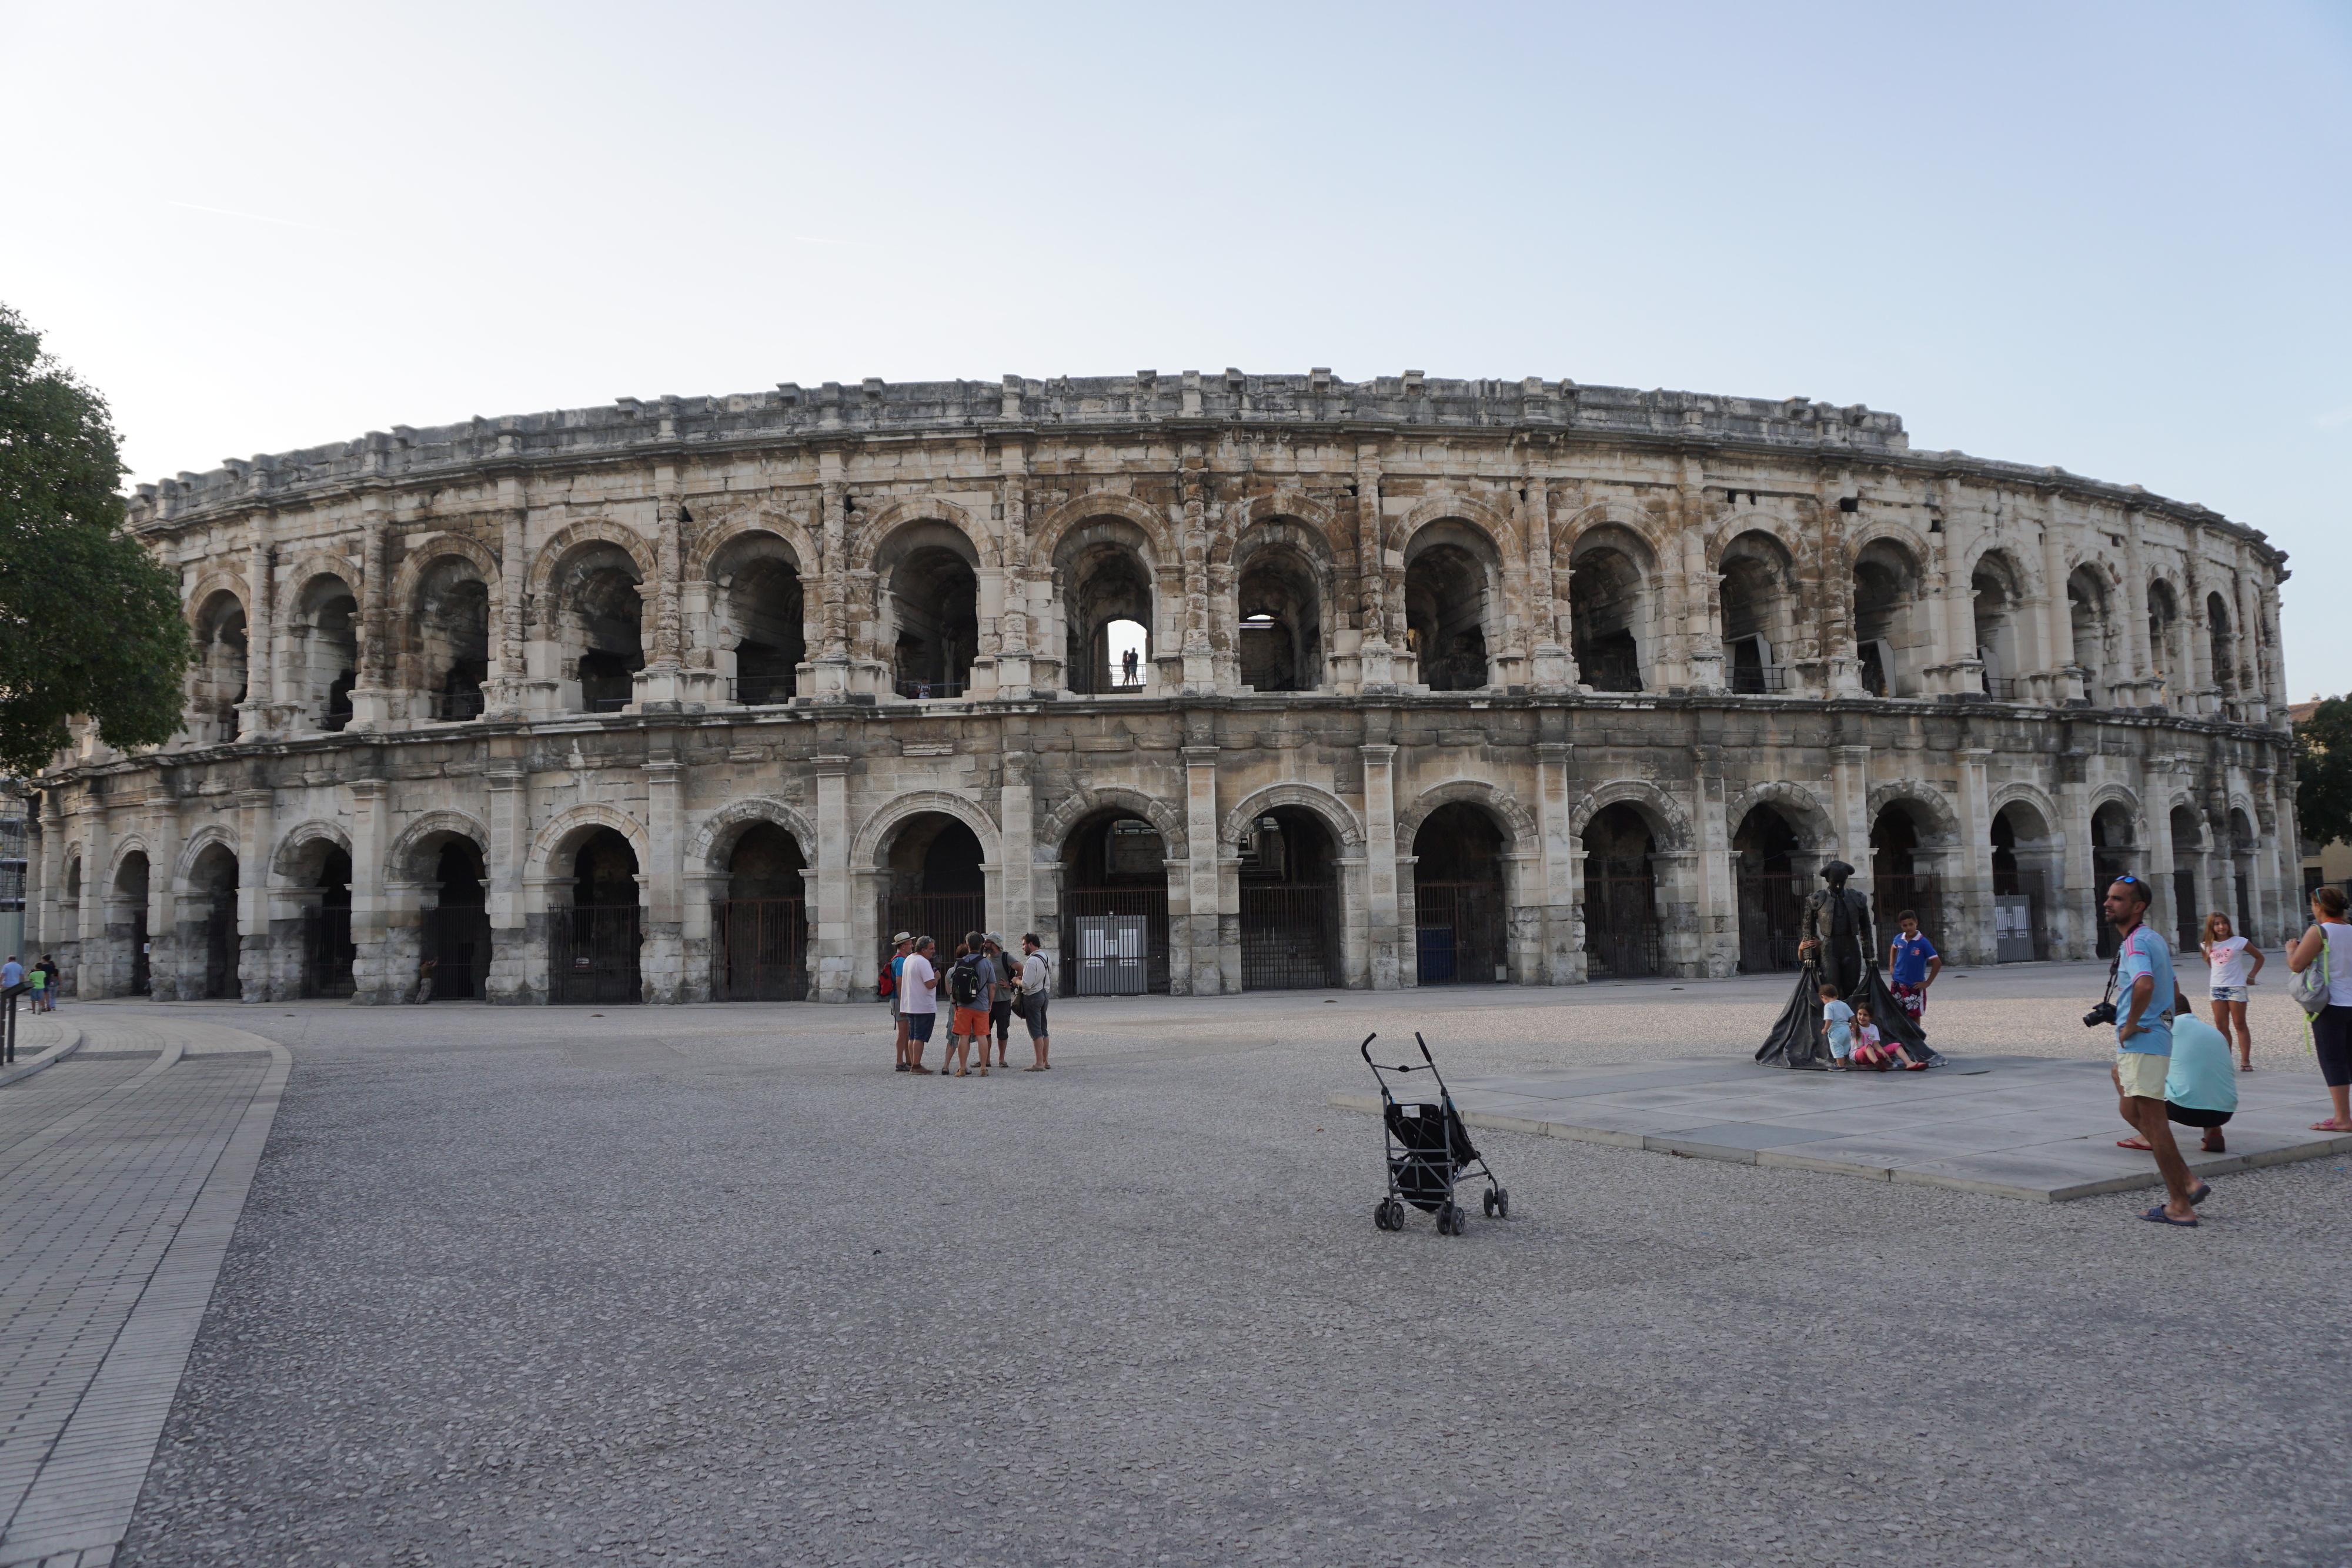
880, 931, 1054, 1079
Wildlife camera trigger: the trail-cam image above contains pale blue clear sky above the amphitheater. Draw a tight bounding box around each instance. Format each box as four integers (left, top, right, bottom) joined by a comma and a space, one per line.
0, 0, 2352, 701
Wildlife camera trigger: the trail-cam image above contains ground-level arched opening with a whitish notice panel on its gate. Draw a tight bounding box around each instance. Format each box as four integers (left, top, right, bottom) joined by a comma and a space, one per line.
1061, 808, 1169, 997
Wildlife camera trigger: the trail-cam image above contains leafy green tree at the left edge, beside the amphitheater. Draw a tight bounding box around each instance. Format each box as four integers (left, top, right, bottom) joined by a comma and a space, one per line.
0, 306, 195, 776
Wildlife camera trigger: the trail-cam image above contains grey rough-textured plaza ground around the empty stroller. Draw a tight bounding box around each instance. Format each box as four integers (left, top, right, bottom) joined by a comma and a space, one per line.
0, 966, 2352, 1568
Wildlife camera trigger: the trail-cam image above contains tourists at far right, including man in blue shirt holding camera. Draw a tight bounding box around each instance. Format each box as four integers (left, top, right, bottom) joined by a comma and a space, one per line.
2084, 877, 2352, 1227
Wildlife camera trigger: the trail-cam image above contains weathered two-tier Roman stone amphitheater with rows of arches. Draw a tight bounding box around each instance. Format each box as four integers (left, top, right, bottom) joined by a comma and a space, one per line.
28, 369, 2298, 1004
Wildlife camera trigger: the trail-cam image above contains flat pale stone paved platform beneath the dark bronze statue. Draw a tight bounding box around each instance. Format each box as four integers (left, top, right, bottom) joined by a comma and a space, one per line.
1331, 1055, 2352, 1203
